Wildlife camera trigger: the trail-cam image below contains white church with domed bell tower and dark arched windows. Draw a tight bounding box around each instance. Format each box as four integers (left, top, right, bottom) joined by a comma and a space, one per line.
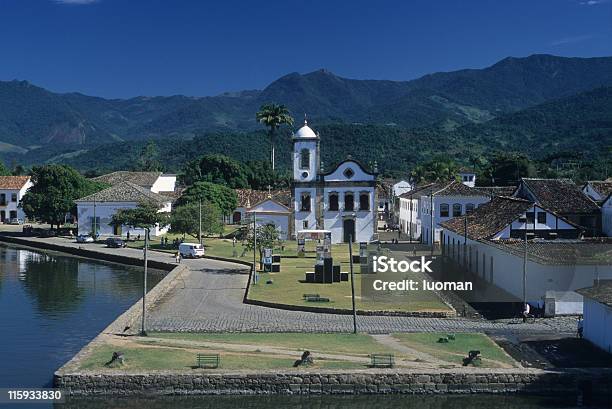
291, 121, 377, 243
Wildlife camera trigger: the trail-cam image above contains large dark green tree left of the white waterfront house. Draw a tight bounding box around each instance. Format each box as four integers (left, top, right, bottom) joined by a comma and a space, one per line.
20, 164, 106, 228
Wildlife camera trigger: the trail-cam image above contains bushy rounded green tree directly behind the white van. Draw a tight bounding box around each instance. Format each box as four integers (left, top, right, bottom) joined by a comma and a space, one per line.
170, 202, 223, 239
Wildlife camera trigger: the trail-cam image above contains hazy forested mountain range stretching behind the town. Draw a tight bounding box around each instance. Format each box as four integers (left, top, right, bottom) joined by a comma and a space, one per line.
0, 55, 612, 172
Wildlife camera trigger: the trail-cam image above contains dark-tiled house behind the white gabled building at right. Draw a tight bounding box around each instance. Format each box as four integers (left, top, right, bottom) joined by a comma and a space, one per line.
513, 178, 601, 236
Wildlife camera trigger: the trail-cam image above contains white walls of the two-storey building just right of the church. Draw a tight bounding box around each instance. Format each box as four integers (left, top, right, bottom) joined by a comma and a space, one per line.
419, 195, 491, 244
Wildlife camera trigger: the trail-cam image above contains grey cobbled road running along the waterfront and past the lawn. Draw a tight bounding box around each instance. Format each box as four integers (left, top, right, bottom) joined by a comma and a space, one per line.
0, 233, 575, 336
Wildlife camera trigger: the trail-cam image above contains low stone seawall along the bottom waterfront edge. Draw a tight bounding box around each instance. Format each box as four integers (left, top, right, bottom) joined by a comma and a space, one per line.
54, 369, 612, 396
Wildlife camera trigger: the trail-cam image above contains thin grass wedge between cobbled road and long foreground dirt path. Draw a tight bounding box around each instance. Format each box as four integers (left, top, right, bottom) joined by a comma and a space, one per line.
151, 333, 395, 355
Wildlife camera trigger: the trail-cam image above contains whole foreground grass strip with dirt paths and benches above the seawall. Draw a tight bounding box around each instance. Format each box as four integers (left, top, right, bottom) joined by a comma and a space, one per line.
74, 333, 516, 371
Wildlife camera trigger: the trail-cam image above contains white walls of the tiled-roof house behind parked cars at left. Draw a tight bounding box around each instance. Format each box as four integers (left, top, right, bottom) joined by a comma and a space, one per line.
77, 202, 171, 237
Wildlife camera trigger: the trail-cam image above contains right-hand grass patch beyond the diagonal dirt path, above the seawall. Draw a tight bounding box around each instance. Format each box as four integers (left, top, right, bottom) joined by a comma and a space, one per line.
393, 333, 516, 368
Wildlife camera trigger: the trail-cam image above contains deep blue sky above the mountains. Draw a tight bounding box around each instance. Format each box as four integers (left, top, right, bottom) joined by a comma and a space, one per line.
0, 0, 612, 98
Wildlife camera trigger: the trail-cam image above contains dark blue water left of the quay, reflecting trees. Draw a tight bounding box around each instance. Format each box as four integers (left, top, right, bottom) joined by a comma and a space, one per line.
0, 242, 163, 388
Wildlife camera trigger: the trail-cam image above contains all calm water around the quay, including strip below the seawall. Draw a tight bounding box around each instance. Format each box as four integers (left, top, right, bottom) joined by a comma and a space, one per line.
0, 245, 610, 409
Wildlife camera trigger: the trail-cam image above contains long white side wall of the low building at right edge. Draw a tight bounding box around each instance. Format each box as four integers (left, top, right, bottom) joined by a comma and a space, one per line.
444, 230, 612, 302
